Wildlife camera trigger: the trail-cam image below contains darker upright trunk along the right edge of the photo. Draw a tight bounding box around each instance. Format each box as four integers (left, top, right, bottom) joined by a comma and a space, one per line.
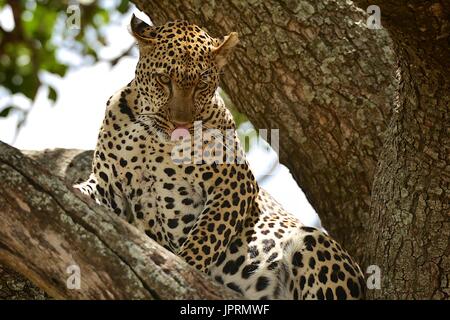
361, 1, 450, 299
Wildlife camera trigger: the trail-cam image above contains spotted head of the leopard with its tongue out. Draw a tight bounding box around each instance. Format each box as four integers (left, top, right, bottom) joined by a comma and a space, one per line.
131, 15, 239, 140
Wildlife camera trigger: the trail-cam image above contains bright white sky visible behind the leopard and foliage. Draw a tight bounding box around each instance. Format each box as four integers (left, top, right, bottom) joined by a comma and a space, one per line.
0, 9, 320, 227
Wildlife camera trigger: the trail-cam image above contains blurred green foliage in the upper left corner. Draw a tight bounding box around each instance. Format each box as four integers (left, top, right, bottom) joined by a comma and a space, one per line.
0, 0, 129, 127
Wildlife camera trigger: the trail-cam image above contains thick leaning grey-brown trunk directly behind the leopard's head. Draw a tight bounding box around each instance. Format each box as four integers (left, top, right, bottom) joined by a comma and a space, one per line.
133, 0, 395, 261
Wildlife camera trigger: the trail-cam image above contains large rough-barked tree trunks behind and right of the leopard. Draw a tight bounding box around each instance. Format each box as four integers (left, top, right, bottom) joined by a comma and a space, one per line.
134, 0, 450, 299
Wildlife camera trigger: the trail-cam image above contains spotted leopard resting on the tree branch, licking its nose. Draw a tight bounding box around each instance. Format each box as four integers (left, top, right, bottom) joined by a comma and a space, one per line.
74, 15, 365, 300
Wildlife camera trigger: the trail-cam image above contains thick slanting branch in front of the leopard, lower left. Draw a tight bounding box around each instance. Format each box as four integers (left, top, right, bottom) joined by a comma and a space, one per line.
0, 142, 243, 299
